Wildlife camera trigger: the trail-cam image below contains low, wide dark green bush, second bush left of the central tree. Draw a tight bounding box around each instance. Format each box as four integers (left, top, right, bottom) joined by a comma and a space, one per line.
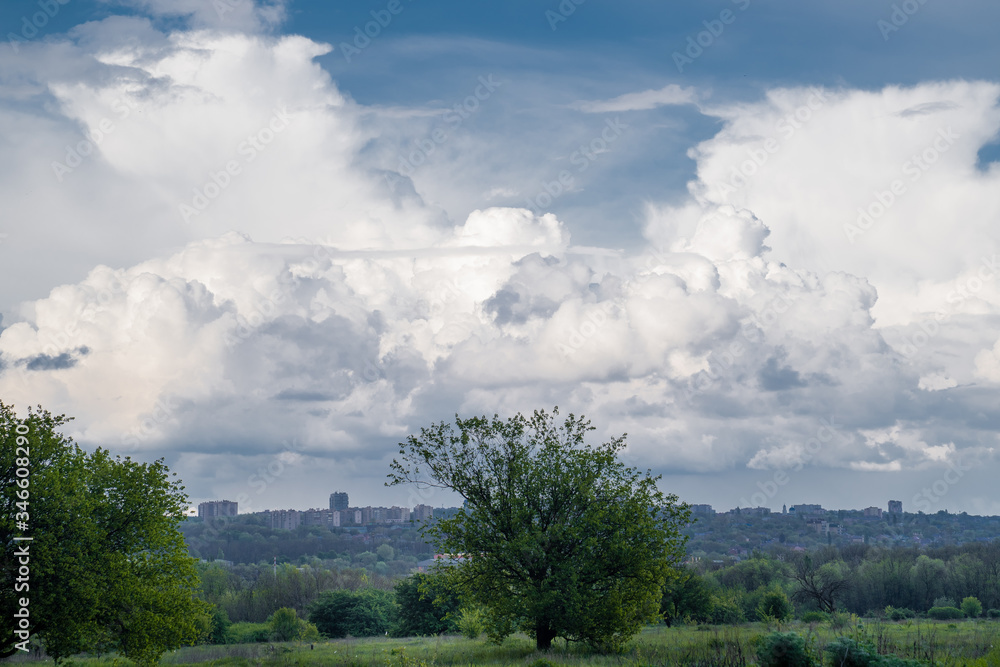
309, 588, 396, 639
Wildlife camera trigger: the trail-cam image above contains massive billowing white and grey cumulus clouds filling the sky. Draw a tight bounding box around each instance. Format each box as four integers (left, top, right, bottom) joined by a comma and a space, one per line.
0, 6, 1000, 512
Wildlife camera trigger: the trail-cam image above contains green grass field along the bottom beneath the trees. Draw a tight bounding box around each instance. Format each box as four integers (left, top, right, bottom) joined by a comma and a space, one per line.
11, 619, 1000, 667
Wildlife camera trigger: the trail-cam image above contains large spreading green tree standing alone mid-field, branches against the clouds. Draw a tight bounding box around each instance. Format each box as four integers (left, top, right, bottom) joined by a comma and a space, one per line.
388, 408, 689, 650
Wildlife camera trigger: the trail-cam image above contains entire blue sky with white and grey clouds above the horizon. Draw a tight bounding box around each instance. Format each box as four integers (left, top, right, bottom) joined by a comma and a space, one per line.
0, 0, 1000, 514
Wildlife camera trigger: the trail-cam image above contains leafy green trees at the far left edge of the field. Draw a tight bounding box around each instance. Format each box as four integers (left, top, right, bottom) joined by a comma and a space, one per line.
0, 403, 210, 664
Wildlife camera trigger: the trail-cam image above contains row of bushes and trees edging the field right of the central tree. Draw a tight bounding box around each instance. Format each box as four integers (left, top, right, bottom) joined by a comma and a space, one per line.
664, 540, 1000, 623
